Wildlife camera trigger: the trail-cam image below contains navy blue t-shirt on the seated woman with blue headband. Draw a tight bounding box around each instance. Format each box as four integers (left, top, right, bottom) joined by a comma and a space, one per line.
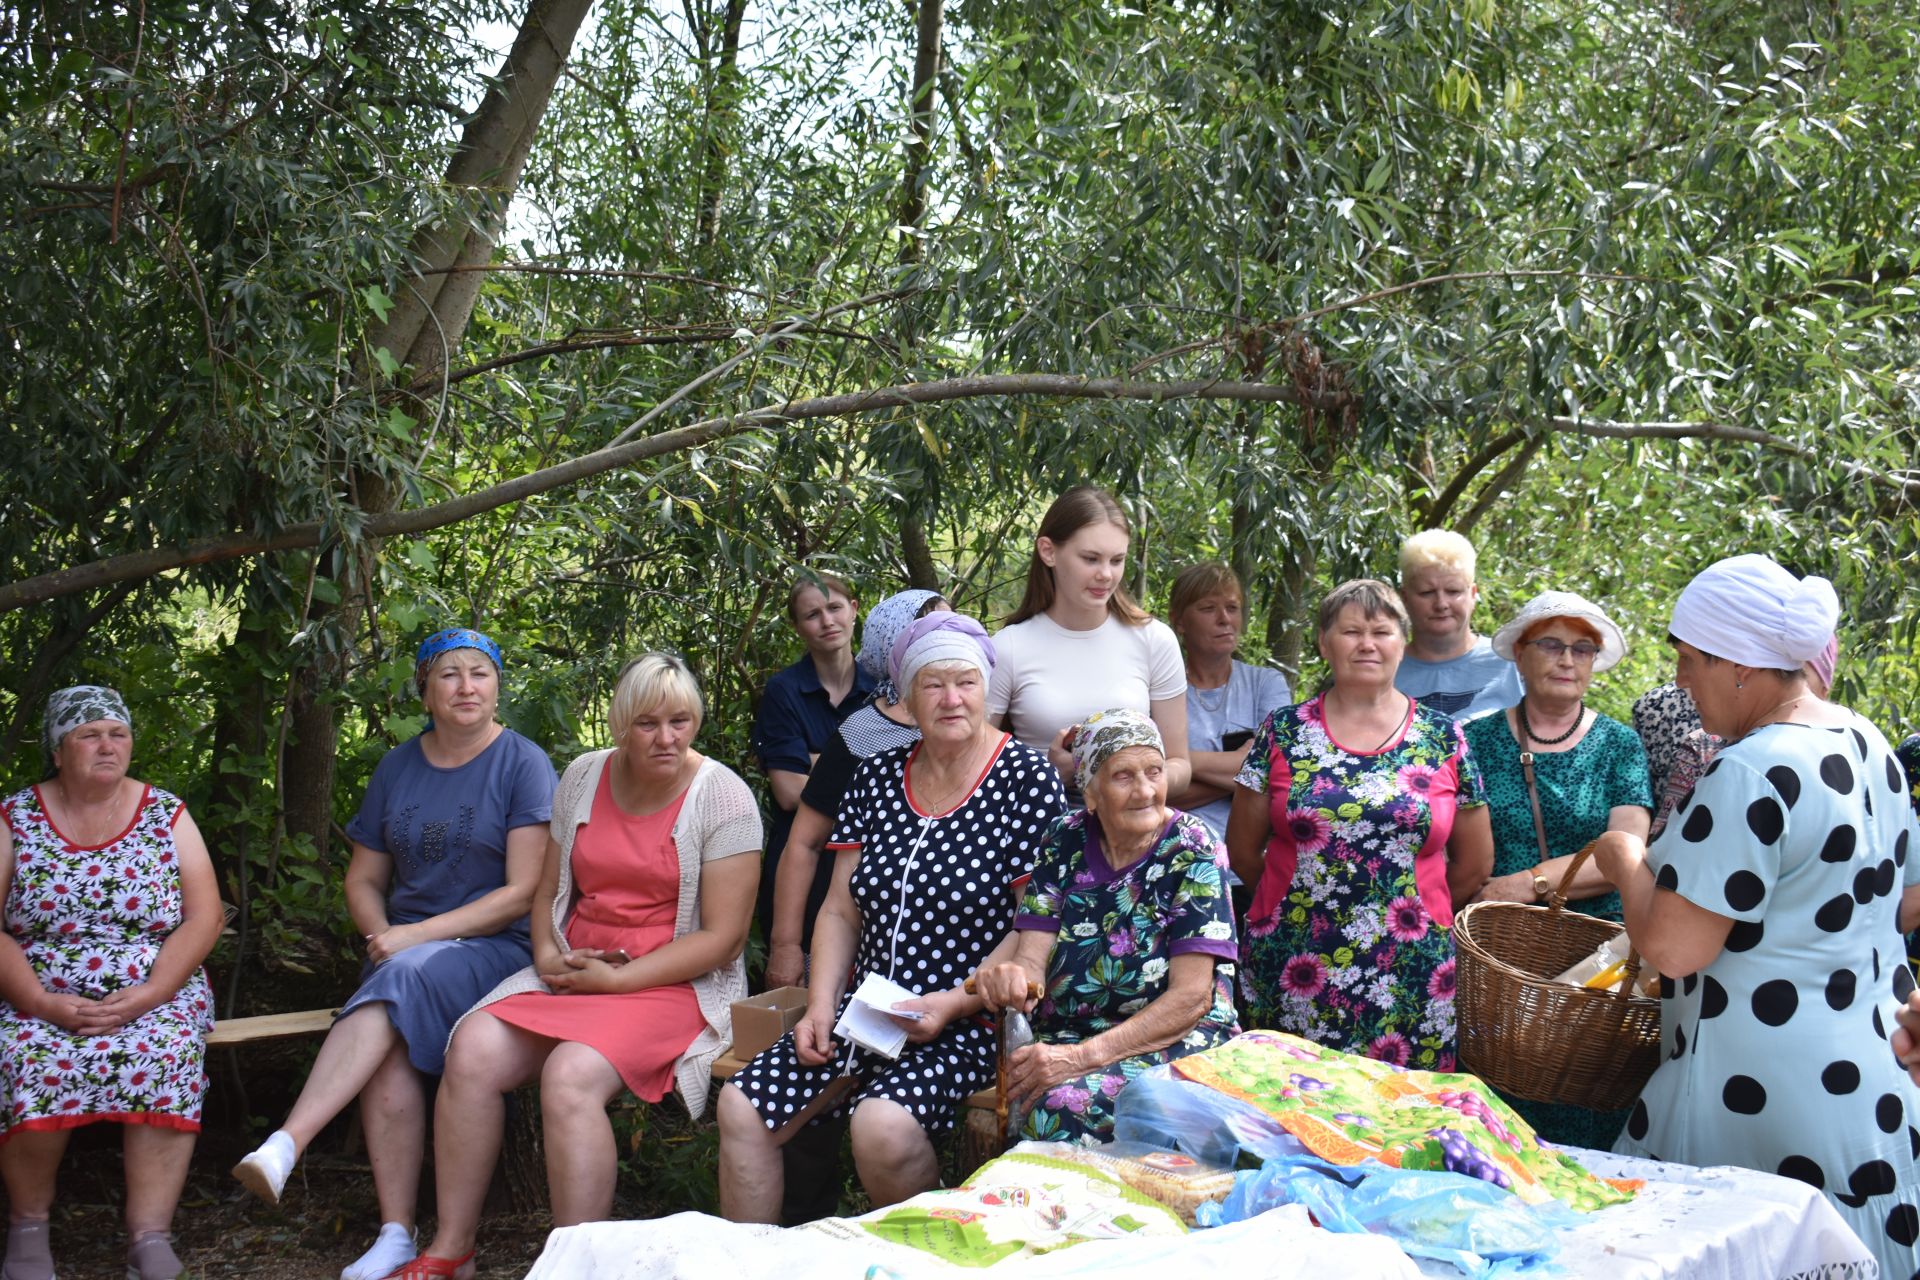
348, 729, 559, 938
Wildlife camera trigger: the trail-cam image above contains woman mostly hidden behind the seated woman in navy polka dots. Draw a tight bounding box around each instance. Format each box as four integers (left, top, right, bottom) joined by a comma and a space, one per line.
766, 589, 952, 986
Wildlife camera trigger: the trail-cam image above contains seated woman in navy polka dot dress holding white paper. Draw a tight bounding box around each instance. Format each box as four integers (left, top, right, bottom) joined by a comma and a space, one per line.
718, 614, 1066, 1222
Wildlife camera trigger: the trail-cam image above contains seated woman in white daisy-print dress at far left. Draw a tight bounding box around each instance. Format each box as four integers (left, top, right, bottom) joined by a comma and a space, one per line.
0, 685, 221, 1280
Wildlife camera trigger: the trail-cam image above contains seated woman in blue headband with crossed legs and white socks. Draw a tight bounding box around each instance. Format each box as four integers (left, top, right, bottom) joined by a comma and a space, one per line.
234, 629, 555, 1280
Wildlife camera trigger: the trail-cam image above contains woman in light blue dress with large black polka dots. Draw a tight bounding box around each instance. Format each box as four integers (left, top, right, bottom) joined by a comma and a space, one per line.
1596, 555, 1920, 1276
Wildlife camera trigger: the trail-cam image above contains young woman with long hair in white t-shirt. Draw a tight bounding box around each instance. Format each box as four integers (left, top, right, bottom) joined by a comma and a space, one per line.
987, 486, 1192, 802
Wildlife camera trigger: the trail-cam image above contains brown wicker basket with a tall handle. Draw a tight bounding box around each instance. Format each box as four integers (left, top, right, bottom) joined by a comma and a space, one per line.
1453, 844, 1661, 1111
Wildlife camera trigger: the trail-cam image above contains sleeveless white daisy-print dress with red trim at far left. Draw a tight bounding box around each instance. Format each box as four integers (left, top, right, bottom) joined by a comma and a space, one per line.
0, 787, 213, 1142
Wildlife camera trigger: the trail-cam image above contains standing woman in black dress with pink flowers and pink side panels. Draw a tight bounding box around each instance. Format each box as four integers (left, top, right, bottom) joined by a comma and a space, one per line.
1227, 578, 1494, 1071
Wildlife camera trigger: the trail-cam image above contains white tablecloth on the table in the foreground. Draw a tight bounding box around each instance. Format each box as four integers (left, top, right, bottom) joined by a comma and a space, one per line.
528, 1150, 1874, 1280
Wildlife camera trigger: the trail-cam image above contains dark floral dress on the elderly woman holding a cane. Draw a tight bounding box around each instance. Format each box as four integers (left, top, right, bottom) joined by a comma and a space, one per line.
1014, 810, 1240, 1144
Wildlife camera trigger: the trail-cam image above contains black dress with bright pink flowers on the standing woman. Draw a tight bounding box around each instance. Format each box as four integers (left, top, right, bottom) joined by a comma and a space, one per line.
1235, 699, 1486, 1071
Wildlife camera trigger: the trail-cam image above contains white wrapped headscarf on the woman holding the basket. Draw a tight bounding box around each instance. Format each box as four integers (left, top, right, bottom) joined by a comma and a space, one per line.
1668, 555, 1839, 672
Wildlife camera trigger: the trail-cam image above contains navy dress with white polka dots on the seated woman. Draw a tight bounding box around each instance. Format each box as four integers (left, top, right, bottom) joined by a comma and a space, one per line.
733, 739, 1066, 1134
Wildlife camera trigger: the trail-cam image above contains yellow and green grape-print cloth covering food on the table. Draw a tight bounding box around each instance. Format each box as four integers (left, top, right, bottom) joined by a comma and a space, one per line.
1173, 1031, 1638, 1213
